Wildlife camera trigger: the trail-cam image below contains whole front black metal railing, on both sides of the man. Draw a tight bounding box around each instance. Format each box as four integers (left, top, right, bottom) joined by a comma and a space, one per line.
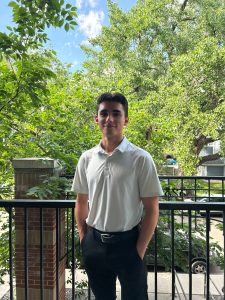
0, 200, 225, 300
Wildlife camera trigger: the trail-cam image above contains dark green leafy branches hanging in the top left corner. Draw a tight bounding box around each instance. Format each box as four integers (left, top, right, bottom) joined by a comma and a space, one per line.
0, 0, 77, 59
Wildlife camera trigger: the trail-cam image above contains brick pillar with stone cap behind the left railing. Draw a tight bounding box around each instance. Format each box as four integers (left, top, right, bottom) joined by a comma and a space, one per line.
13, 158, 65, 300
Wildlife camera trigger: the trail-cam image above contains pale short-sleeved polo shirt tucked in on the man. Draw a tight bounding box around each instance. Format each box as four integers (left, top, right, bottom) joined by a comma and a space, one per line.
72, 138, 163, 232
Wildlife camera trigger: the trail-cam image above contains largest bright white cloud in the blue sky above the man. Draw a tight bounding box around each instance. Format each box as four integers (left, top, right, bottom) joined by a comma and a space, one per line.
78, 10, 104, 38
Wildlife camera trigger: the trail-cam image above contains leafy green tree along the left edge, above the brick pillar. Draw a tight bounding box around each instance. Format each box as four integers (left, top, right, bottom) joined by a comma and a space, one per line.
0, 0, 76, 198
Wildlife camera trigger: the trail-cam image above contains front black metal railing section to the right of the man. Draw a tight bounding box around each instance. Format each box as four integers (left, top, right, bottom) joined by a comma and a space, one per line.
158, 202, 225, 299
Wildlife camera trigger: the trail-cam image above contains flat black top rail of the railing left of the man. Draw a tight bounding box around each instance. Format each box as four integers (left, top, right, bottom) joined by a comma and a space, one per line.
0, 199, 75, 208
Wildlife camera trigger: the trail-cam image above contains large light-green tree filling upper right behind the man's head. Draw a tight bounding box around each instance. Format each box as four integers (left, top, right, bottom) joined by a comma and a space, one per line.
80, 0, 225, 174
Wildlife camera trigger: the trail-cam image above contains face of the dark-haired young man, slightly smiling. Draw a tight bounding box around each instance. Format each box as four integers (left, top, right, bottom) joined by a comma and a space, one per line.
95, 101, 128, 139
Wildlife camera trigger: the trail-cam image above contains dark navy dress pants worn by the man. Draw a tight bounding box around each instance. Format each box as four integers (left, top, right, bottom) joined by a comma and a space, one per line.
81, 227, 148, 300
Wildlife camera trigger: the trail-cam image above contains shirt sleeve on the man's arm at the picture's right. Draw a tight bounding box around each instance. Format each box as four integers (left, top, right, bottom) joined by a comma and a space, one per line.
138, 153, 163, 198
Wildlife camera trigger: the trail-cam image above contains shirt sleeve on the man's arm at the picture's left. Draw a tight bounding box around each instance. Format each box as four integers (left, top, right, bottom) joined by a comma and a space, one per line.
71, 155, 88, 194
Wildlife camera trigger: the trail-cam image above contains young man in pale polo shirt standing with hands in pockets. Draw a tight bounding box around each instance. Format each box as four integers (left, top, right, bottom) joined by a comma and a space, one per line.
72, 93, 162, 300
